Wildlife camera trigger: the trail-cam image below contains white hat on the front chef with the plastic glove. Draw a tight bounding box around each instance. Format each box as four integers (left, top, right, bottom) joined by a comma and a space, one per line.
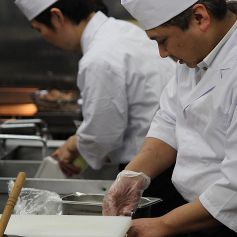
121, 0, 198, 30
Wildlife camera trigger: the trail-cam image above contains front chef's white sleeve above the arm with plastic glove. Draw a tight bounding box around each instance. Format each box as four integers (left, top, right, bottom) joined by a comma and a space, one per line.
146, 78, 177, 149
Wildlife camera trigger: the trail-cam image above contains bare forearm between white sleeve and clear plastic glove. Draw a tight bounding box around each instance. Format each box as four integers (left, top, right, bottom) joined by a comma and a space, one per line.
125, 138, 176, 178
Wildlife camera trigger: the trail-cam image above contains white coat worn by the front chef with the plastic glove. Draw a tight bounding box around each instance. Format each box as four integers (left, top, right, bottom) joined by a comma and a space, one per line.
147, 25, 237, 232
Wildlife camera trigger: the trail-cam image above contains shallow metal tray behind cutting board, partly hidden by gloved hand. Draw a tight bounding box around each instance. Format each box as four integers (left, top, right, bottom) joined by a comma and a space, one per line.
62, 192, 162, 219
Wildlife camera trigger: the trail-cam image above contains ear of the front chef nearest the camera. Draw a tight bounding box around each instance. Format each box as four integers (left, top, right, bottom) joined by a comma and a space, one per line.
192, 4, 211, 32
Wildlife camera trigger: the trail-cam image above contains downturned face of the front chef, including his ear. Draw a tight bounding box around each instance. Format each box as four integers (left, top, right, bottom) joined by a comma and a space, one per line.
146, 4, 209, 67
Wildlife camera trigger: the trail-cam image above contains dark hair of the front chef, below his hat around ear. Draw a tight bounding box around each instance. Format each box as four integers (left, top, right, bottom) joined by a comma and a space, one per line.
162, 0, 228, 31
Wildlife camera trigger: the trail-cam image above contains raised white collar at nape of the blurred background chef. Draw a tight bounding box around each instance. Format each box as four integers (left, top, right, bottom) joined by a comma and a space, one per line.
81, 11, 108, 54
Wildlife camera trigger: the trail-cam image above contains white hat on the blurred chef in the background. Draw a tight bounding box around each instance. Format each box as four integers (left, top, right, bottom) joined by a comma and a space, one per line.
15, 0, 58, 21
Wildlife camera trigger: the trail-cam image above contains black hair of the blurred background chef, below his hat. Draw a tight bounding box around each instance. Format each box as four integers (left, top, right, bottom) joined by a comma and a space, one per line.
34, 0, 108, 28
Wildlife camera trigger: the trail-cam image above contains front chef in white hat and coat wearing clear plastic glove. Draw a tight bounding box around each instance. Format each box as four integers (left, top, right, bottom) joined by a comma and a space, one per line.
103, 0, 237, 237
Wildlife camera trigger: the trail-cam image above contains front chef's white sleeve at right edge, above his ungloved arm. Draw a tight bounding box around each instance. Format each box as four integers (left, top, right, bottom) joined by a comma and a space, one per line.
199, 90, 237, 232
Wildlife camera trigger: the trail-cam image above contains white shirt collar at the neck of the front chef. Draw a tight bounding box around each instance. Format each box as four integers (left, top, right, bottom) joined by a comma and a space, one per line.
197, 21, 237, 71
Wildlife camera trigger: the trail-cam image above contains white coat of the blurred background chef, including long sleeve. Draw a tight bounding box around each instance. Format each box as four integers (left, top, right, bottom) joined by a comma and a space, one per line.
77, 12, 176, 169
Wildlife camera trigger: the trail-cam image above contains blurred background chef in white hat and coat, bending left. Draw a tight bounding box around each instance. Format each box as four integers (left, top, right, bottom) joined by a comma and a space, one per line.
15, 0, 176, 175
